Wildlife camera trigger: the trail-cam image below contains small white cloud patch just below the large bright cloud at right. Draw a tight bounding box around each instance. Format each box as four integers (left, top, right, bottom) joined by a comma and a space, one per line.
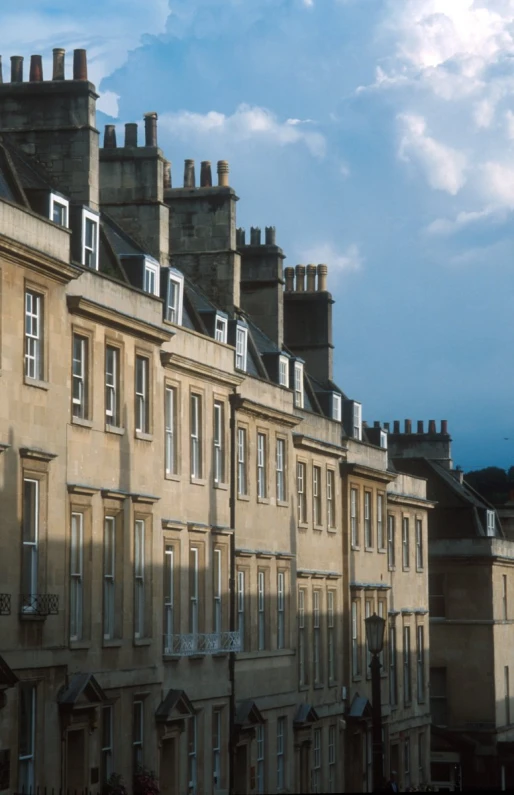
398, 113, 467, 196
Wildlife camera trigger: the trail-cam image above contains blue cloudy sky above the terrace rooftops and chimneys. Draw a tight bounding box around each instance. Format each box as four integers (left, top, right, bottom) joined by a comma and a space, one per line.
0, 0, 514, 469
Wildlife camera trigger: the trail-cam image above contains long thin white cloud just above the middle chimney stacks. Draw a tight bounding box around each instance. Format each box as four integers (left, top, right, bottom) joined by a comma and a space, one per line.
159, 104, 326, 158
